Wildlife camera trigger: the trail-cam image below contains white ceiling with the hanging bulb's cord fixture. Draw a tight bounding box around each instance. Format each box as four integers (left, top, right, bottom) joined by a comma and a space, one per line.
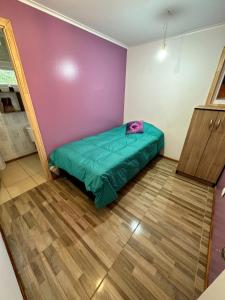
19, 0, 225, 46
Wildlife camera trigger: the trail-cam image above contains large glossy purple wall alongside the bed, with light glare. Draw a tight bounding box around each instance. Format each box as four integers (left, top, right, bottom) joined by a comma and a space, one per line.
0, 0, 127, 153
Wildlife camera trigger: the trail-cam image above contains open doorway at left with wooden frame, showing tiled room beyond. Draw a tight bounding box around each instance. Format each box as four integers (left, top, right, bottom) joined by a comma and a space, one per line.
0, 18, 49, 204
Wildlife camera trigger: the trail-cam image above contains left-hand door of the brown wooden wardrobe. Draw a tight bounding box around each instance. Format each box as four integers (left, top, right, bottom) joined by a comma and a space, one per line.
177, 109, 218, 176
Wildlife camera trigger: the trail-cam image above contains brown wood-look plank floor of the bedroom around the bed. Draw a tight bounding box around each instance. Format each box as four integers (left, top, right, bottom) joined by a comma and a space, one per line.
0, 158, 213, 300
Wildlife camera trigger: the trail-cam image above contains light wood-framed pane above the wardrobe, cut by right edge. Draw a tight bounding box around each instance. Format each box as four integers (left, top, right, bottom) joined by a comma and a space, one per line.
206, 47, 225, 106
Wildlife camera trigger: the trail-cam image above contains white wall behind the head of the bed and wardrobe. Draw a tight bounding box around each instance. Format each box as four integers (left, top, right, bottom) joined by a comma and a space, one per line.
124, 25, 225, 159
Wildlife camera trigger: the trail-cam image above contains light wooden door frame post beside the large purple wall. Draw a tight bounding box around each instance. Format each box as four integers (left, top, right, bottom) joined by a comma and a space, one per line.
0, 17, 51, 179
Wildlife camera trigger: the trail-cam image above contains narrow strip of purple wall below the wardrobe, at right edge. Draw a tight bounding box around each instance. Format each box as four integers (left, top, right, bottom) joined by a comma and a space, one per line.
209, 170, 225, 284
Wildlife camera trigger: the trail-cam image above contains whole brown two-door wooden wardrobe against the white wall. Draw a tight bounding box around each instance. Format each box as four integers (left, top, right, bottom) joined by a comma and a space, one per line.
177, 106, 225, 184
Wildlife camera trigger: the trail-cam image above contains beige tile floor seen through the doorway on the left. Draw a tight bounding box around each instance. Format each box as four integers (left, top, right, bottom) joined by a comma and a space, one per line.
0, 154, 46, 204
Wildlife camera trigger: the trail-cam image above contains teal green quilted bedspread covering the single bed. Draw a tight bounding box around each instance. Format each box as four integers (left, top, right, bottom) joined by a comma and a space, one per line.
49, 123, 164, 208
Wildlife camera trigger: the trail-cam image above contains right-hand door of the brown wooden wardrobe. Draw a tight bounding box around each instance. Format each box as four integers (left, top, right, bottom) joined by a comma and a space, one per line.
196, 112, 225, 183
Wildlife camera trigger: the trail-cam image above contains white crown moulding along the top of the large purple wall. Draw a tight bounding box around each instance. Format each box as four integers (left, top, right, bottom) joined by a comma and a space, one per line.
18, 0, 128, 49
